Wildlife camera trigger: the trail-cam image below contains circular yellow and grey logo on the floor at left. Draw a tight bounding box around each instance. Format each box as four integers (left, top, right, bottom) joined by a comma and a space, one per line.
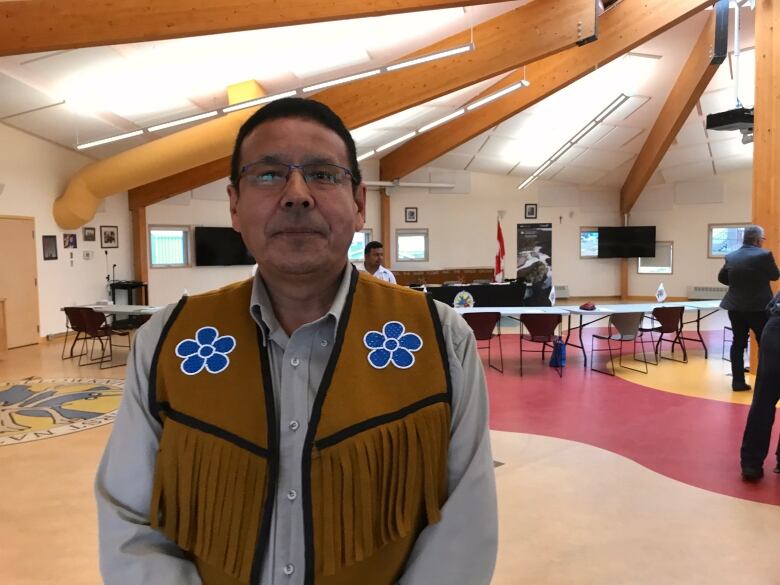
0, 378, 124, 446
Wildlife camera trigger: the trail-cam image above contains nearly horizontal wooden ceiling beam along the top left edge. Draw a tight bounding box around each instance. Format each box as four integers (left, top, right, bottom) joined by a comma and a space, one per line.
0, 0, 503, 56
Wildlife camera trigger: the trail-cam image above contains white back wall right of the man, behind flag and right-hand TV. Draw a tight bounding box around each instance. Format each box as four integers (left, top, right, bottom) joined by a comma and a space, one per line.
385, 169, 751, 297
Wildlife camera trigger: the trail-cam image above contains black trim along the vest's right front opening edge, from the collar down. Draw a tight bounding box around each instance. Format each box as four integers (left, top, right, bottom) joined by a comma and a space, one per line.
301, 264, 358, 585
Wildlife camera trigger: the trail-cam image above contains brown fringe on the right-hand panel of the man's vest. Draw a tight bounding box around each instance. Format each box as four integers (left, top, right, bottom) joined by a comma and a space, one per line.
312, 403, 450, 575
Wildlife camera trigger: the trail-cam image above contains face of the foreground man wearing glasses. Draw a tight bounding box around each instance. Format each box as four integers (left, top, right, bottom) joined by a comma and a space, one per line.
228, 118, 365, 278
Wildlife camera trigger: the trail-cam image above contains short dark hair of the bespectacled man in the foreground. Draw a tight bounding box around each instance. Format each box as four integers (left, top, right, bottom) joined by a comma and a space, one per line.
225, 98, 361, 188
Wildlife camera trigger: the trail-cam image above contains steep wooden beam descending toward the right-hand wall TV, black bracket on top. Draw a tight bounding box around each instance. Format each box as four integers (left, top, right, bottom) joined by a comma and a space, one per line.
620, 0, 729, 215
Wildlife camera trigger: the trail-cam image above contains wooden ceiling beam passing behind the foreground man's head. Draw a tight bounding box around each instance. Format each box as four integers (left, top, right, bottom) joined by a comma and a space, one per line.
129, 0, 600, 209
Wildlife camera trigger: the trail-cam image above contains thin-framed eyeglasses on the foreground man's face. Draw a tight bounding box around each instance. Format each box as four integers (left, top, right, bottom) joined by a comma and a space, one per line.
239, 162, 356, 192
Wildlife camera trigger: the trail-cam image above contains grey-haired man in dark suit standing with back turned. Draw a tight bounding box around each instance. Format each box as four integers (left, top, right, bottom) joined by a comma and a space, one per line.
718, 225, 780, 391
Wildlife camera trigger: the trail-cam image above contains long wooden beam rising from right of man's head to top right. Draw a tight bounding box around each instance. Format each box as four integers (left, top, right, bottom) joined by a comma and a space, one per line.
380, 0, 712, 181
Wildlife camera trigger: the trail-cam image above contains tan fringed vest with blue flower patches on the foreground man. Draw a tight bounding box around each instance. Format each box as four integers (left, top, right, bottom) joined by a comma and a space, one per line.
149, 269, 451, 585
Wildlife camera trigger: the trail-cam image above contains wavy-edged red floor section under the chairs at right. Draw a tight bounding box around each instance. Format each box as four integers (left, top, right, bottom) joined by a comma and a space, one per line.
480, 332, 780, 505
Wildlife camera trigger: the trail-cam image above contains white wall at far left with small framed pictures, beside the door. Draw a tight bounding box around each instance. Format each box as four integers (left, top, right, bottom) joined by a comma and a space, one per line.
0, 124, 133, 336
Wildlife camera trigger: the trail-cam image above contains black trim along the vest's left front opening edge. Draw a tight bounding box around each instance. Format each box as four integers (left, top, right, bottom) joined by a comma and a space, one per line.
250, 325, 279, 583
